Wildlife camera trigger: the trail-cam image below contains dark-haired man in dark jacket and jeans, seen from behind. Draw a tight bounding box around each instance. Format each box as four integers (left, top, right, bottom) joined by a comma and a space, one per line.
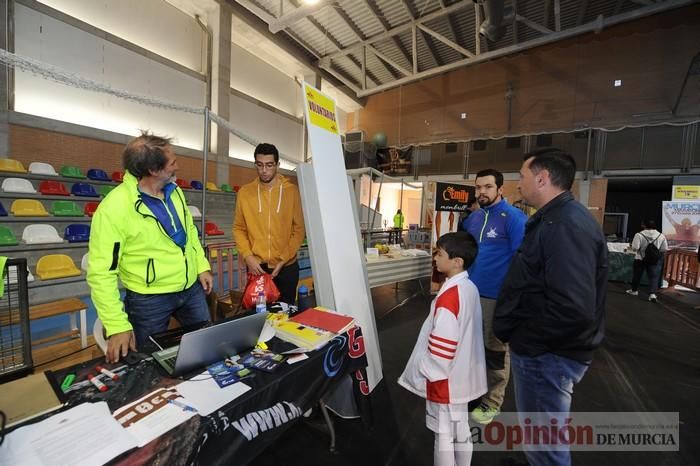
493, 149, 608, 465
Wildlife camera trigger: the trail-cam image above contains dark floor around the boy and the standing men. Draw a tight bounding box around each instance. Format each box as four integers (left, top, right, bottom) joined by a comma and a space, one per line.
254, 282, 700, 466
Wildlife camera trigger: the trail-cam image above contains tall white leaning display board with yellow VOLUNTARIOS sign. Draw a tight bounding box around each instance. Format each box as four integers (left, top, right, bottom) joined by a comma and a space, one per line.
299, 82, 382, 390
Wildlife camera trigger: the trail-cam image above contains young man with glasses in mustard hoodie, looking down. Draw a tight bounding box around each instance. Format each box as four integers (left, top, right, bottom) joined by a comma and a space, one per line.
233, 143, 304, 304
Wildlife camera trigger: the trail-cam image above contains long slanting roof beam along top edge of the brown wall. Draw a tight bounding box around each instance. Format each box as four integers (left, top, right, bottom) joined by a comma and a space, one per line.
358, 0, 696, 97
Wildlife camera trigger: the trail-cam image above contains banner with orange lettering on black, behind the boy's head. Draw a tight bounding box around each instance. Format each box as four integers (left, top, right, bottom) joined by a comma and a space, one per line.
430, 182, 475, 291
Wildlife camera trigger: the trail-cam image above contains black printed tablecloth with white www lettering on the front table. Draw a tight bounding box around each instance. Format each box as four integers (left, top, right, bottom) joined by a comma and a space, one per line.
51, 327, 369, 465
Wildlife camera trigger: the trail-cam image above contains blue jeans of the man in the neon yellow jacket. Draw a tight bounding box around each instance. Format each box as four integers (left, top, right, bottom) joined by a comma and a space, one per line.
124, 281, 210, 349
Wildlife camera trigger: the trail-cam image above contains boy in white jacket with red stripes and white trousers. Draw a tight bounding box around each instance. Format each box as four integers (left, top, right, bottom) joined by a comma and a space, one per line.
399, 231, 487, 466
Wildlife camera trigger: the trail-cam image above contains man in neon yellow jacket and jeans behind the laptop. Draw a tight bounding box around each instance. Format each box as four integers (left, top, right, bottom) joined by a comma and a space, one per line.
87, 132, 213, 362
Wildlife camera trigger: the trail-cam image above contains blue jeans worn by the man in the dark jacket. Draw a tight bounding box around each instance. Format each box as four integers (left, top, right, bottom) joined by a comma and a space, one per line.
510, 350, 588, 466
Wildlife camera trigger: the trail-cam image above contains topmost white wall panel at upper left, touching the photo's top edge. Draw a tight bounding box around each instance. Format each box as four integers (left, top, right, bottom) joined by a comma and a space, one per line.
41, 0, 206, 72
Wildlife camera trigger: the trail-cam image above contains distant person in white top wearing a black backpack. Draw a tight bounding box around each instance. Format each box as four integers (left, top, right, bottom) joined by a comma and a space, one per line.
626, 220, 668, 303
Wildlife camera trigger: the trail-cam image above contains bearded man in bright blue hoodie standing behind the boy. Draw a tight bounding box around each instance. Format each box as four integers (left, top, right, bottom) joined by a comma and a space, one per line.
463, 169, 527, 424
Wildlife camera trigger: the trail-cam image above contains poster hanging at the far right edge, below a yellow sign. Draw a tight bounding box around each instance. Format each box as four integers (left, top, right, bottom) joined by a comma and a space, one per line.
661, 201, 700, 250
